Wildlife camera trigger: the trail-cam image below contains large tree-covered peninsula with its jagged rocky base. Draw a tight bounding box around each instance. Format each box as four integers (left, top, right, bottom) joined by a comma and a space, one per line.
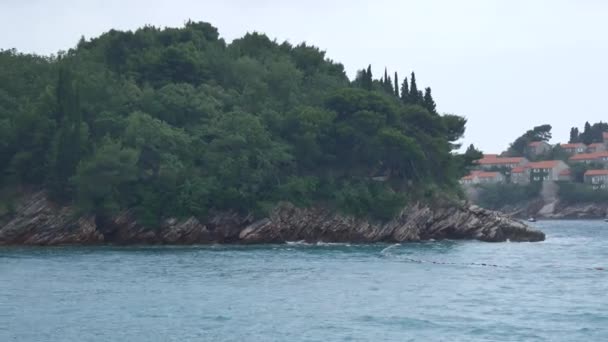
0, 22, 544, 245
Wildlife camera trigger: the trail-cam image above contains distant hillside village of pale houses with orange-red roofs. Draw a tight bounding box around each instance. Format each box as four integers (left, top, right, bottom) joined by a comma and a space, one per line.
460, 132, 608, 191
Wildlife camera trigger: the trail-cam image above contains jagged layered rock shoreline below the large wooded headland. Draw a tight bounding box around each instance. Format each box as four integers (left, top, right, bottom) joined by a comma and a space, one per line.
0, 192, 545, 245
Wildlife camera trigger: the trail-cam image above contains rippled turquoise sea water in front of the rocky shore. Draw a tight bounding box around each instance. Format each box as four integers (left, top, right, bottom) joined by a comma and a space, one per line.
0, 221, 608, 342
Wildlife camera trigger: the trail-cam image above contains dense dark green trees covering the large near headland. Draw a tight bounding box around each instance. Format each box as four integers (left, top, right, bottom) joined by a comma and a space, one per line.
0, 22, 471, 225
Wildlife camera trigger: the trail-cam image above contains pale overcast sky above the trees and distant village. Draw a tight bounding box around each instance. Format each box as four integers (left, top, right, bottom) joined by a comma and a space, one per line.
0, 0, 608, 152
